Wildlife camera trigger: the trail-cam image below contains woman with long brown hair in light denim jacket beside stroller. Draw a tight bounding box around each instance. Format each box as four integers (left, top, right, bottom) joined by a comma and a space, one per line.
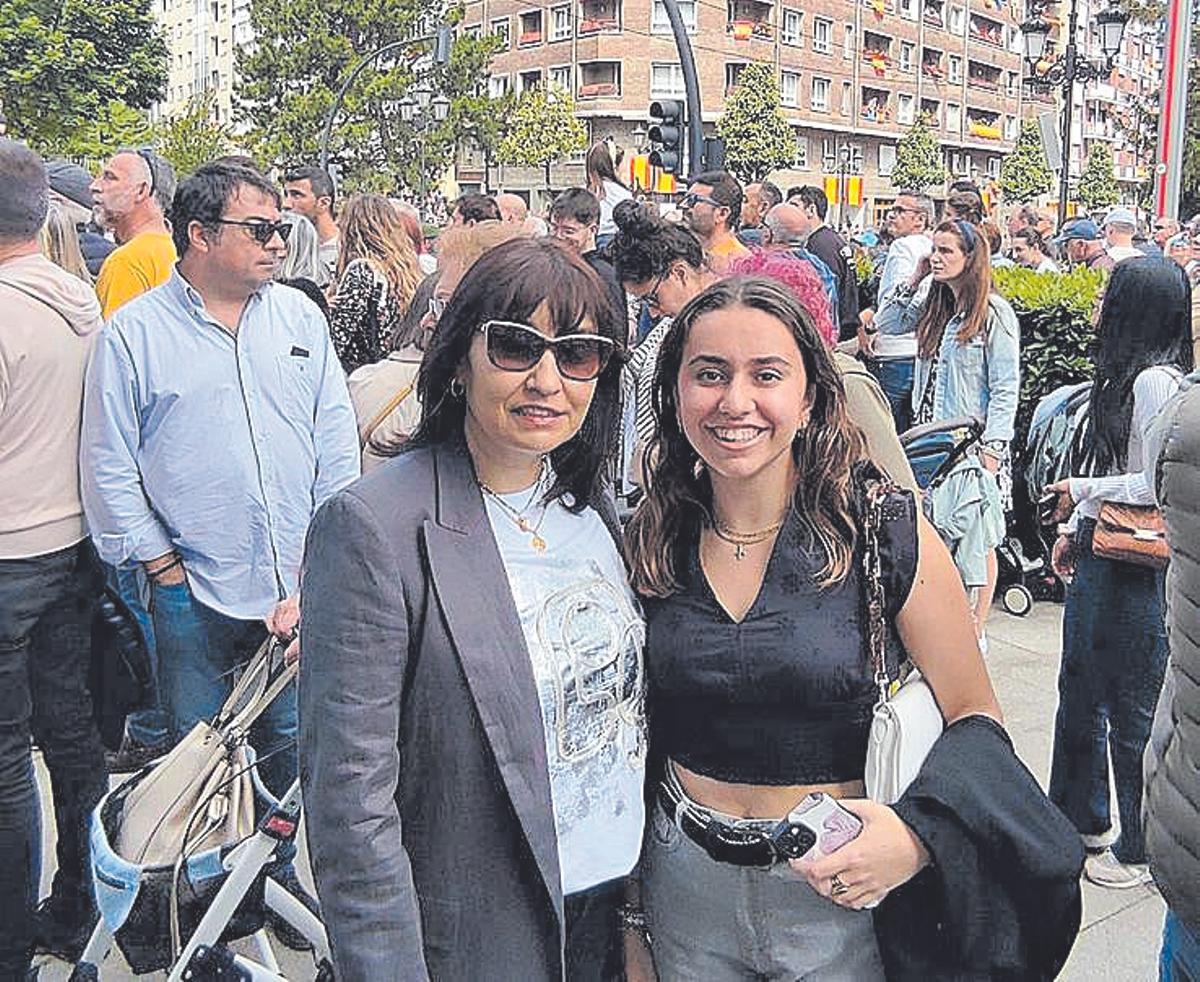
912, 218, 1021, 652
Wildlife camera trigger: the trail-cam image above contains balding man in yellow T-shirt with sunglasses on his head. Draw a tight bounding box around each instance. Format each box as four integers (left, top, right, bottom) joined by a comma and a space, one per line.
90, 150, 178, 321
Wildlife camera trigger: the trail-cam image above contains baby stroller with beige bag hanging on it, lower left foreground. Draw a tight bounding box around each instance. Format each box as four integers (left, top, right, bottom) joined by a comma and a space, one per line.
71, 637, 334, 982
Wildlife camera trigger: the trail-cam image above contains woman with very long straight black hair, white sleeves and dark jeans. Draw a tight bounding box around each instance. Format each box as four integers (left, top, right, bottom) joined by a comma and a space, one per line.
1046, 259, 1193, 887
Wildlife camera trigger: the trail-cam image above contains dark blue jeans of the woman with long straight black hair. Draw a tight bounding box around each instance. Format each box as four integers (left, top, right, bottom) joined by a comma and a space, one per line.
1050, 520, 1168, 863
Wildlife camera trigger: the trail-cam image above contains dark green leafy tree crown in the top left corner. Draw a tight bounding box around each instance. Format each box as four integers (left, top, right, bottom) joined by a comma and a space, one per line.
0, 0, 167, 154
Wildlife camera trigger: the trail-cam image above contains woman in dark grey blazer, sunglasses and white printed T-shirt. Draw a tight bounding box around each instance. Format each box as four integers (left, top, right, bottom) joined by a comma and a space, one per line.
300, 239, 644, 982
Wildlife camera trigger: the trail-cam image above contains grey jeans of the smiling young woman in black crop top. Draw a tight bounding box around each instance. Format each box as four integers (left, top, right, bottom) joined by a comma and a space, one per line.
642, 804, 883, 982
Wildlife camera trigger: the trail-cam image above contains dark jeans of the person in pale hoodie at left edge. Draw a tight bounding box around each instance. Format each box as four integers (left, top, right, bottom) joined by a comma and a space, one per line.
0, 539, 108, 980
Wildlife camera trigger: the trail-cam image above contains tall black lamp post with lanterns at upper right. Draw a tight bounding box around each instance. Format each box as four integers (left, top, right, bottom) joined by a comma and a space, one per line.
1021, 0, 1129, 226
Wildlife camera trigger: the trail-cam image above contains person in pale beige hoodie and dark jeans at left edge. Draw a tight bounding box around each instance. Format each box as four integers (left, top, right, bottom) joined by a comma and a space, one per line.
0, 139, 108, 980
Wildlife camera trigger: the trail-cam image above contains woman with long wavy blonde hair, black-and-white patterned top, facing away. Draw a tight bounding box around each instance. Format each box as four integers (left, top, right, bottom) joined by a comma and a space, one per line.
329, 194, 420, 373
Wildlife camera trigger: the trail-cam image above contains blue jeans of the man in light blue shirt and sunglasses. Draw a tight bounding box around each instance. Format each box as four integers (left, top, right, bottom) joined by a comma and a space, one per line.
150, 582, 298, 796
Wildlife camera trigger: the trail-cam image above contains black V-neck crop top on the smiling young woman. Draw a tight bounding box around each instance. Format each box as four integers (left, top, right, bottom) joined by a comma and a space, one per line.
644, 491, 917, 785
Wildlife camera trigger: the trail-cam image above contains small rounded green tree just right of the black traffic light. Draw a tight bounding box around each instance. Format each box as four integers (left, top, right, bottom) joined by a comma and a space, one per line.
716, 61, 796, 184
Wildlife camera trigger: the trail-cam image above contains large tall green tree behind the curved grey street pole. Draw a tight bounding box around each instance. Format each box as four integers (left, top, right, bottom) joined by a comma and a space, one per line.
235, 0, 498, 190
